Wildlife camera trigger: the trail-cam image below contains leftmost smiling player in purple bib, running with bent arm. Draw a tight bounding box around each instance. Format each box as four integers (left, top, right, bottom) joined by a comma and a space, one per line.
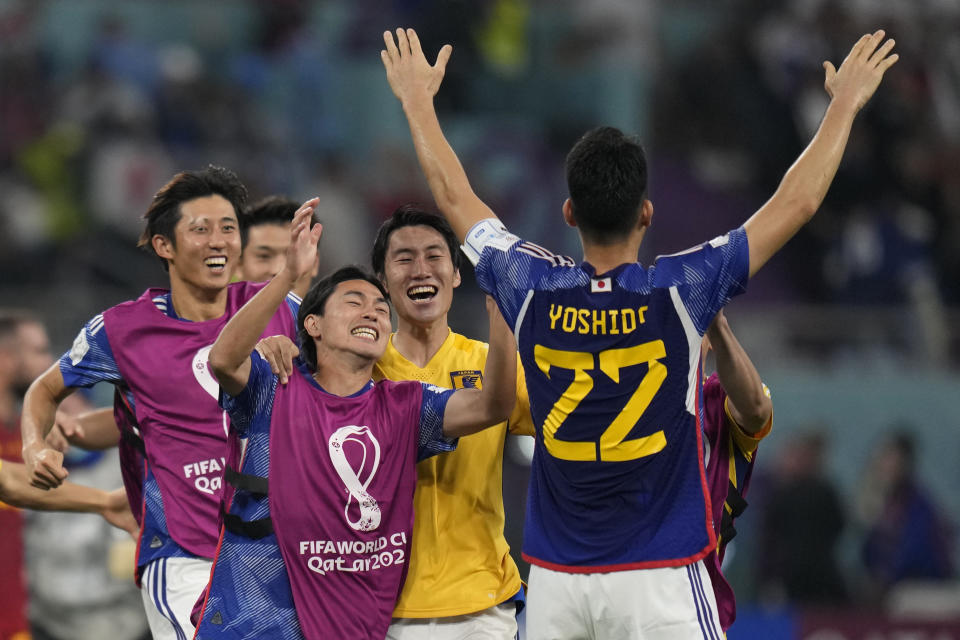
22, 167, 299, 640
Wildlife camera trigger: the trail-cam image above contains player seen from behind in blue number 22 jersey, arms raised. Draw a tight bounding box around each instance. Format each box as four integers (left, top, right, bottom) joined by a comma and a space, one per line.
381, 29, 897, 640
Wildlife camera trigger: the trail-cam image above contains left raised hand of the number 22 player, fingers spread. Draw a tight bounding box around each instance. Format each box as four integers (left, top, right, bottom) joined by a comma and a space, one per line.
380, 29, 453, 104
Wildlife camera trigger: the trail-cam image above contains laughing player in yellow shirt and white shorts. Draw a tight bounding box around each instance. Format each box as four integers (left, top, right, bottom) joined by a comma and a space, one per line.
371, 205, 533, 640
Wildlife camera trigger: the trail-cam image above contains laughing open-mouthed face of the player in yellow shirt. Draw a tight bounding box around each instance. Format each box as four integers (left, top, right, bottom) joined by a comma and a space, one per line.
383, 225, 460, 326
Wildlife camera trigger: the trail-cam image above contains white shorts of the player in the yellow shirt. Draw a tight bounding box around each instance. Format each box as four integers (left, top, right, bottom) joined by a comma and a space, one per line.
386, 602, 517, 640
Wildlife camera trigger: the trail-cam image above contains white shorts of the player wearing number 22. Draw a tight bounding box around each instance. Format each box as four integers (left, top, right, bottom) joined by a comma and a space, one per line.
526, 562, 724, 640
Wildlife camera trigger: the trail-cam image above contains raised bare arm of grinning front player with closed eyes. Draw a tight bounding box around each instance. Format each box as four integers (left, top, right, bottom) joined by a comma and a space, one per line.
209, 198, 322, 396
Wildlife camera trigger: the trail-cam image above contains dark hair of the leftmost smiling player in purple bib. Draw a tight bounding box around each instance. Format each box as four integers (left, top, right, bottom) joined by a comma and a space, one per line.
137, 164, 247, 270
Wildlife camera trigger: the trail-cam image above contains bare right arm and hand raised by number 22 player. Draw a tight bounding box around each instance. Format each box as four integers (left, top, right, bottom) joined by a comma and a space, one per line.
744, 30, 899, 276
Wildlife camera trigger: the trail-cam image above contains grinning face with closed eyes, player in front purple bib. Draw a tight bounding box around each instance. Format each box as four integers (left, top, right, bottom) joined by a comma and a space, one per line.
304, 280, 390, 366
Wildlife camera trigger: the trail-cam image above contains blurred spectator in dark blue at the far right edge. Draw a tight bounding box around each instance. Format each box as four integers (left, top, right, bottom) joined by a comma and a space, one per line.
857, 428, 954, 603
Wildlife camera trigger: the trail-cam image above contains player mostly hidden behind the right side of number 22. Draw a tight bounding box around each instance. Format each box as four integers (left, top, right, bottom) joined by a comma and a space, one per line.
701, 311, 773, 632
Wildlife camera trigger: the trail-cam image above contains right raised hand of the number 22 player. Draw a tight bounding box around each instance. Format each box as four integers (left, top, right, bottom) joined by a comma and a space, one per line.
823, 29, 900, 111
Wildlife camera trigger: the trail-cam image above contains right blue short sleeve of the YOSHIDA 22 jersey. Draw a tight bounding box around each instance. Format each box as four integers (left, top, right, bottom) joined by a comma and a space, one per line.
655, 227, 750, 336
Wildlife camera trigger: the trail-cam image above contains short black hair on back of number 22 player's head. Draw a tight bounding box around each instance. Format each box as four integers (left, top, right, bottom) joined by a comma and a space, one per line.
566, 127, 647, 244
